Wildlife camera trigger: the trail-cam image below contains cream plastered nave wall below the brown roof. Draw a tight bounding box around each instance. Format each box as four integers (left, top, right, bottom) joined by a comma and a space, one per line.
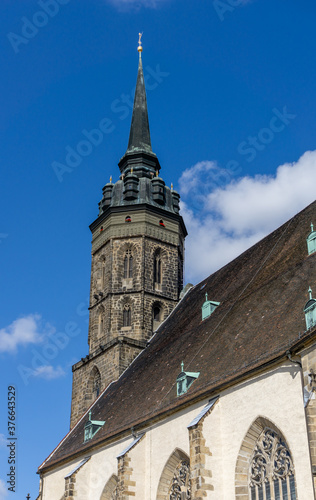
42, 364, 314, 500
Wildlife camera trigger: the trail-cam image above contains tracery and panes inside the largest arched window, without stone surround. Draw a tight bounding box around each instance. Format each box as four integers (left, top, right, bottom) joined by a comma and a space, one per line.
249, 428, 297, 500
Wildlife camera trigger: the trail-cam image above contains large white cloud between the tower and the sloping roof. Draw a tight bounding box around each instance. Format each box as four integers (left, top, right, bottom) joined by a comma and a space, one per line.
179, 151, 316, 282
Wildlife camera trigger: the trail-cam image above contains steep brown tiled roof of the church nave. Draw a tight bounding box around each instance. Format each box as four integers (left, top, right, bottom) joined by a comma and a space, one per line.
40, 202, 316, 470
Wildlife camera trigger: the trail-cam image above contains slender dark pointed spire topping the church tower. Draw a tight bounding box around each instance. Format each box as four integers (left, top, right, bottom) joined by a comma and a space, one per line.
127, 51, 152, 153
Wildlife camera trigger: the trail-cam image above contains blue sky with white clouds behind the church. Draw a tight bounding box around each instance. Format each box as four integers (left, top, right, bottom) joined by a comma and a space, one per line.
0, 0, 316, 500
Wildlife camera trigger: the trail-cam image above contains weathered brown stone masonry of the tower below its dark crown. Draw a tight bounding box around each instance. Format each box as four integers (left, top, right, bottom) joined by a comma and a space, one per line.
71, 207, 184, 426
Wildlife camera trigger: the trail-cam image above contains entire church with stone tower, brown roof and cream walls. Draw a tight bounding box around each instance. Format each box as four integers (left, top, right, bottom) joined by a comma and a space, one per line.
38, 39, 316, 500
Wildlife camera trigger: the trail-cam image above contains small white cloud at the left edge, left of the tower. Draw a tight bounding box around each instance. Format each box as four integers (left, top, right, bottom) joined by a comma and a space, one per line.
0, 314, 43, 353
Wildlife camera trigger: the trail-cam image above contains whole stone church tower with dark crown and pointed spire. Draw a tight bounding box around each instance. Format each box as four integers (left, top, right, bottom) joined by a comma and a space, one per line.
70, 40, 187, 427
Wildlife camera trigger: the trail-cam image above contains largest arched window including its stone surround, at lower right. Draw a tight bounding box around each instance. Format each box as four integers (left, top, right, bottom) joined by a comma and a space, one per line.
235, 417, 297, 500
